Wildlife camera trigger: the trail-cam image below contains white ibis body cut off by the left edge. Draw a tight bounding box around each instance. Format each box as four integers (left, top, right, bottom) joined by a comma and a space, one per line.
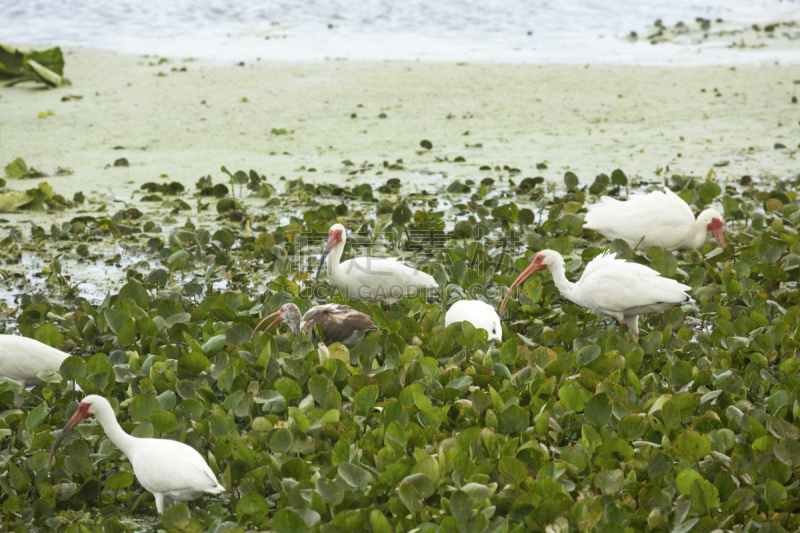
0, 335, 69, 389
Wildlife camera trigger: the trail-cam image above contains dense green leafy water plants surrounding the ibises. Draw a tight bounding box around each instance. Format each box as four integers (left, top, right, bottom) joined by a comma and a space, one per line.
0, 162, 800, 533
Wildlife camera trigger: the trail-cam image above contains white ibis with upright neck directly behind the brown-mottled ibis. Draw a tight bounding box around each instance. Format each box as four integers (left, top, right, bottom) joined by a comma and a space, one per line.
317, 224, 438, 304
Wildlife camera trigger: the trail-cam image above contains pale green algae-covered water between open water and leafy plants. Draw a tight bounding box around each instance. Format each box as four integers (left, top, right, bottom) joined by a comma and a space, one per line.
0, 49, 800, 205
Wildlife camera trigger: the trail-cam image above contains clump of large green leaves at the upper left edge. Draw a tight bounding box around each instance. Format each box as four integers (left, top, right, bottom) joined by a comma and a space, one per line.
0, 43, 70, 87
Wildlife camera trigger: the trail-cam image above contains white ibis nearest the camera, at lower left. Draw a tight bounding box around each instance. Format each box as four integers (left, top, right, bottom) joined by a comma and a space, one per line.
47, 395, 225, 514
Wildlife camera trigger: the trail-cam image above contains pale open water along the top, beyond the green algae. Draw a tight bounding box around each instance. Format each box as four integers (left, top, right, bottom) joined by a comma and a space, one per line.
6, 0, 800, 65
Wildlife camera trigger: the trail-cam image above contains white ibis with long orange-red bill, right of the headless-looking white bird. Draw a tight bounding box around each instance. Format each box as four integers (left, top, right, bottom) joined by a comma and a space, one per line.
500, 250, 692, 337
